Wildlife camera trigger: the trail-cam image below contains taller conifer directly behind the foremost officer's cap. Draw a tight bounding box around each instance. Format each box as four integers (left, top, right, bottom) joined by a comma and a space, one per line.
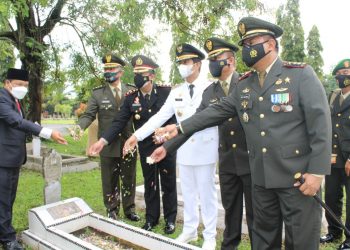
276, 0, 305, 62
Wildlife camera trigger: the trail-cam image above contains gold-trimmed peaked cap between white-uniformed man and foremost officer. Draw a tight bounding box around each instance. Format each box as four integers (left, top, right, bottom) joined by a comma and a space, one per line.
204, 37, 239, 58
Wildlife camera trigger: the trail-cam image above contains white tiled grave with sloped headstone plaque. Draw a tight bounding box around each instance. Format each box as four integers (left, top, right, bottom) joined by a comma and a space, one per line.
22, 198, 200, 250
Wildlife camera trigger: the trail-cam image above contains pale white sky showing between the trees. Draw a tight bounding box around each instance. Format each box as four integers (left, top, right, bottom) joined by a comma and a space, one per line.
19, 0, 350, 82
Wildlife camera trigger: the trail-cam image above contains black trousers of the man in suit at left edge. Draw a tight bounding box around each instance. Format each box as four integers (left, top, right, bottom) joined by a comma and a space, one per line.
0, 167, 20, 243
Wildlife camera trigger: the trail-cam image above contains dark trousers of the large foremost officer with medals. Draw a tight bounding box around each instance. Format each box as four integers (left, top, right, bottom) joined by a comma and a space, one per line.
253, 185, 322, 250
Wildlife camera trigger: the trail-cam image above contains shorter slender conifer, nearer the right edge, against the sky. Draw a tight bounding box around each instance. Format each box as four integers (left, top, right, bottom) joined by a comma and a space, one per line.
306, 25, 323, 80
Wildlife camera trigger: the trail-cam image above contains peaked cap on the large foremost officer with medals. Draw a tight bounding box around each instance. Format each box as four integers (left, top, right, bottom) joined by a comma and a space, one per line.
237, 17, 283, 46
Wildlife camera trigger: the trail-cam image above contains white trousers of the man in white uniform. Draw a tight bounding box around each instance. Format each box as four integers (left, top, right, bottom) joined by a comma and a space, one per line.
178, 163, 218, 240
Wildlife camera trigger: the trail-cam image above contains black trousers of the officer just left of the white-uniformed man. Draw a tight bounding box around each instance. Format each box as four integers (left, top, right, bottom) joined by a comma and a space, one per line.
141, 154, 177, 224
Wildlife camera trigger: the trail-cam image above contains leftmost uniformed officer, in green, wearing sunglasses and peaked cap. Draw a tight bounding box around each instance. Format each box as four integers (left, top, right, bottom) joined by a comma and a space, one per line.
78, 54, 140, 221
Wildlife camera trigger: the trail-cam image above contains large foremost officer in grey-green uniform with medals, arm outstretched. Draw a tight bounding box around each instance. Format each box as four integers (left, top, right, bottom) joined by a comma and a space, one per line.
152, 17, 331, 250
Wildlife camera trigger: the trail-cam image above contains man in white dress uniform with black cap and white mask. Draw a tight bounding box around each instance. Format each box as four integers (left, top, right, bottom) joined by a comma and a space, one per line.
124, 43, 218, 250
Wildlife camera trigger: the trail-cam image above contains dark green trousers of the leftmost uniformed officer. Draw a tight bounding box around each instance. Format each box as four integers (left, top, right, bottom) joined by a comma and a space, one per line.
100, 156, 136, 215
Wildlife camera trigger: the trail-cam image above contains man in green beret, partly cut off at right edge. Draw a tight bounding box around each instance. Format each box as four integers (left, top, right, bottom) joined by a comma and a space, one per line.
320, 59, 350, 249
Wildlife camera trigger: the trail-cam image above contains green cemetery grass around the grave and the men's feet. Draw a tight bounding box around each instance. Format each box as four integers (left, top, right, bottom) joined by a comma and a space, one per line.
14, 134, 340, 250
